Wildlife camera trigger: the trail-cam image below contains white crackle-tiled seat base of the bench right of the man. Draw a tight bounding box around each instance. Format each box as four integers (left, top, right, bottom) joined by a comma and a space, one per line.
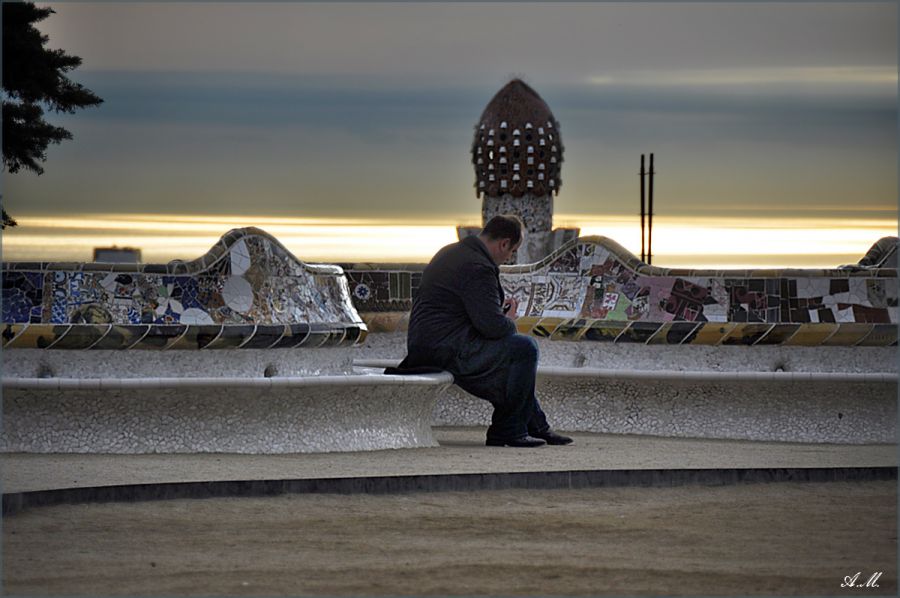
354, 359, 898, 444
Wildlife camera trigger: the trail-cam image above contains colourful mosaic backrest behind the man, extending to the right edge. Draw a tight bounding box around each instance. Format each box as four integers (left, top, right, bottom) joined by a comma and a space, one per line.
346, 237, 897, 346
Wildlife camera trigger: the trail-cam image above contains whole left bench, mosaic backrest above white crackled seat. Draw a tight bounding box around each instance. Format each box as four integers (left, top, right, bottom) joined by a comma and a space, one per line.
0, 228, 452, 453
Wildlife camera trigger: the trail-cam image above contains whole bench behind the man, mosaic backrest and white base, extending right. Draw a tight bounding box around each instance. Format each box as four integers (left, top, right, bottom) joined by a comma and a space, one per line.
345, 237, 898, 443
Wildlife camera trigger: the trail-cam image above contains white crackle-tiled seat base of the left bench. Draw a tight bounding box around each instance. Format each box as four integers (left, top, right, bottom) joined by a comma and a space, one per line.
0, 373, 453, 454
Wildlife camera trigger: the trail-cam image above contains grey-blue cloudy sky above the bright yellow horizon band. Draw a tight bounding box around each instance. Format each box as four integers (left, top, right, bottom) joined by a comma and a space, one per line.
4, 2, 898, 262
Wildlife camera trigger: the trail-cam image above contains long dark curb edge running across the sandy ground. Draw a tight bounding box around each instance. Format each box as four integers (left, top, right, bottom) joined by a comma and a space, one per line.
3, 467, 897, 516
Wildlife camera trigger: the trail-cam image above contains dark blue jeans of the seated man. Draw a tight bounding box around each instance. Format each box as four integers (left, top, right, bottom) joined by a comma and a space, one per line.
404, 334, 550, 440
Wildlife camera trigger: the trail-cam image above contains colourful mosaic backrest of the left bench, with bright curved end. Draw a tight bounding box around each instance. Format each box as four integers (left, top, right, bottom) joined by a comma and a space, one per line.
0, 228, 366, 350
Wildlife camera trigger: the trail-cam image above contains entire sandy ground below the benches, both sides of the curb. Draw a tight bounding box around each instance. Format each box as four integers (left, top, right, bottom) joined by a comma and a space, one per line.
2, 428, 897, 596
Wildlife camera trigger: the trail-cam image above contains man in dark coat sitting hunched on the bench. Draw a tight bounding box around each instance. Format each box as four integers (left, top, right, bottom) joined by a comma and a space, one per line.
398, 216, 572, 447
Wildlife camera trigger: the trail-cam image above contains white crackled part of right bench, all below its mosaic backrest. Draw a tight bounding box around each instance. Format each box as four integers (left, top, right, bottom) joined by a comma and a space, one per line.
356, 333, 897, 444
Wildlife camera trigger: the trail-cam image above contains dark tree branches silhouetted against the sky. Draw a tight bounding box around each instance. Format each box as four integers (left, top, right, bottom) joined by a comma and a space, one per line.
2, 2, 103, 228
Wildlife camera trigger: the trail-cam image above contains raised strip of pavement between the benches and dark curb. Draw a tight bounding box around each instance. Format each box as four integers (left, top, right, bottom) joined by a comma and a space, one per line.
2, 427, 898, 500
